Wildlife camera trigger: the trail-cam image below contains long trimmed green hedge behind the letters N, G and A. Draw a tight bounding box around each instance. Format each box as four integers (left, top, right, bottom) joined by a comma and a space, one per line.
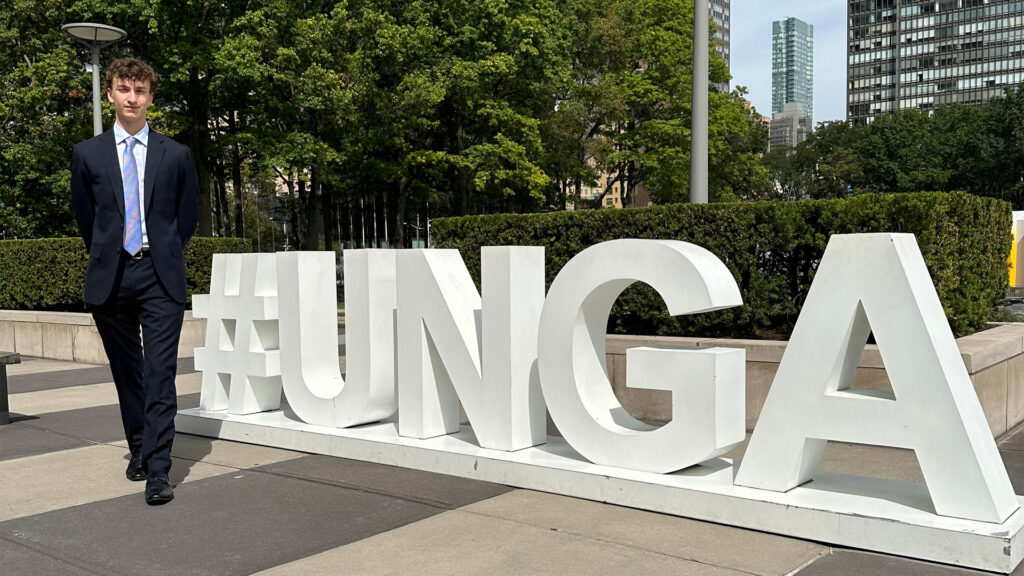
431, 193, 1012, 337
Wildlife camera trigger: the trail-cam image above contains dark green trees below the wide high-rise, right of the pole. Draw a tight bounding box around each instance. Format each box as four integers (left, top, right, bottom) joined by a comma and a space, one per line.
763, 86, 1024, 208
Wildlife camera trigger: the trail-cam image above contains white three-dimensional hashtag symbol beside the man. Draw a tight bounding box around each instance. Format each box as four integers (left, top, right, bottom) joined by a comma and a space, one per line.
193, 254, 282, 414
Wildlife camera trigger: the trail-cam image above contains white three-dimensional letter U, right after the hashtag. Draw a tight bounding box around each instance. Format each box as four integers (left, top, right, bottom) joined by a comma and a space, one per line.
278, 250, 396, 427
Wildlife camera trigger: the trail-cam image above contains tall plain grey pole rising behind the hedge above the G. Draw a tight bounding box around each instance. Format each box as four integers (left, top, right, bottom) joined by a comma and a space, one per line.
690, 0, 711, 204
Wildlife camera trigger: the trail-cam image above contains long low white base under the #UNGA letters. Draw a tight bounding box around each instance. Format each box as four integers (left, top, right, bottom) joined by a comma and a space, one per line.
175, 408, 1024, 574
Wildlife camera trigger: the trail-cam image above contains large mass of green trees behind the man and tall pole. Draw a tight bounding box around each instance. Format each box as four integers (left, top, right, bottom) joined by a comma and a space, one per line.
0, 0, 767, 243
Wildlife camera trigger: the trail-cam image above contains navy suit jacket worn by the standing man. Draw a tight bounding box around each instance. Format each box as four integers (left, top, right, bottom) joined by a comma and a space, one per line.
71, 129, 199, 304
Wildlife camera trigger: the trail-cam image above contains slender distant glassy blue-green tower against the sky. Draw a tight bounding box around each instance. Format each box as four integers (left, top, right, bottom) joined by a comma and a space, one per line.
771, 18, 814, 120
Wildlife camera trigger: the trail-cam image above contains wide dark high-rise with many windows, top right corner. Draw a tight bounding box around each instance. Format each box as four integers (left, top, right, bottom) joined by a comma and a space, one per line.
846, 0, 1024, 124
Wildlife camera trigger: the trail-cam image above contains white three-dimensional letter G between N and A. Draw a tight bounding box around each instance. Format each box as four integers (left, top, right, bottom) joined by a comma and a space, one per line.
538, 240, 744, 472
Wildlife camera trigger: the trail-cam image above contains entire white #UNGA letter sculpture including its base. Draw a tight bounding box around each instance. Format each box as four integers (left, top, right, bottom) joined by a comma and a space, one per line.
188, 234, 1024, 573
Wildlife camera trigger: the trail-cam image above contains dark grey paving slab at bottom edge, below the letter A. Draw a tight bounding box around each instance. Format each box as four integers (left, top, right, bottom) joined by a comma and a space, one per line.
797, 549, 1007, 576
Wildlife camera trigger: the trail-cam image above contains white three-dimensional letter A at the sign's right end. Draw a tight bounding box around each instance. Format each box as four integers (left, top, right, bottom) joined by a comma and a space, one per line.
736, 234, 1018, 523
